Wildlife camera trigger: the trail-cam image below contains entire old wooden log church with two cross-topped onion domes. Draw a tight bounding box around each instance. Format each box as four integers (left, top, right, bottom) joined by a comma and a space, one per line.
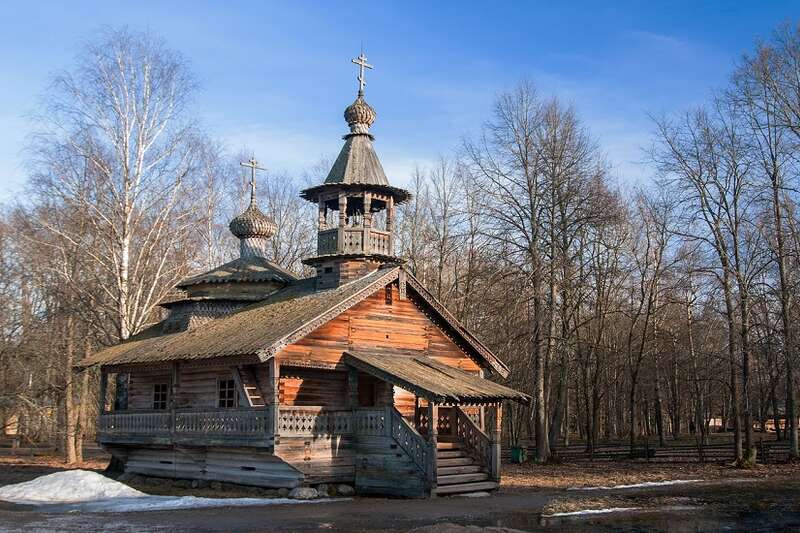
81, 54, 529, 497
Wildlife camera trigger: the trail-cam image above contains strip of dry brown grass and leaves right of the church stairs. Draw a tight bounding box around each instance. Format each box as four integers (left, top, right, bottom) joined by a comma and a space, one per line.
502, 461, 800, 491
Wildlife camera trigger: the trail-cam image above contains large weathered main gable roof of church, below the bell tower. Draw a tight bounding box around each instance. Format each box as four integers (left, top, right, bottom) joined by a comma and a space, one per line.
78, 266, 508, 377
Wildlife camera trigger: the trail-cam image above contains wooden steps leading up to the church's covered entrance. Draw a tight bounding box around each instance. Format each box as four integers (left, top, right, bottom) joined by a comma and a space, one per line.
434, 437, 499, 496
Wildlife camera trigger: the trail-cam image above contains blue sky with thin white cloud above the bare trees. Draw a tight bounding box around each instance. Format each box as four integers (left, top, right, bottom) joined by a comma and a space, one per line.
0, 0, 800, 201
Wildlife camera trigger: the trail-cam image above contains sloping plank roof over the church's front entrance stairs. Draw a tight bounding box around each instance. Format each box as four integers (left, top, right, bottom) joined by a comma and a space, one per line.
344, 350, 531, 404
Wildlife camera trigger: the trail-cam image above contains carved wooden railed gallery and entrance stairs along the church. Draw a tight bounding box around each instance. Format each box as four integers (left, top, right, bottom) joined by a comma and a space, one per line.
98, 403, 500, 494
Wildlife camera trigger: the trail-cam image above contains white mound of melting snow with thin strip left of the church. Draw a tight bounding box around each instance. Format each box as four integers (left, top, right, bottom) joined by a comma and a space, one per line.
0, 470, 348, 513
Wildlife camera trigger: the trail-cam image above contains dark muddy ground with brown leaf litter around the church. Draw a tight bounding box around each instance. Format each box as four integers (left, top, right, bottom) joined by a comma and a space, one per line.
0, 457, 800, 533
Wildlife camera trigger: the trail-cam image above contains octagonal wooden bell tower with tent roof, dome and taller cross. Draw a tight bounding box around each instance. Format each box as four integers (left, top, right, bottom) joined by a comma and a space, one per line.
301, 52, 411, 289
